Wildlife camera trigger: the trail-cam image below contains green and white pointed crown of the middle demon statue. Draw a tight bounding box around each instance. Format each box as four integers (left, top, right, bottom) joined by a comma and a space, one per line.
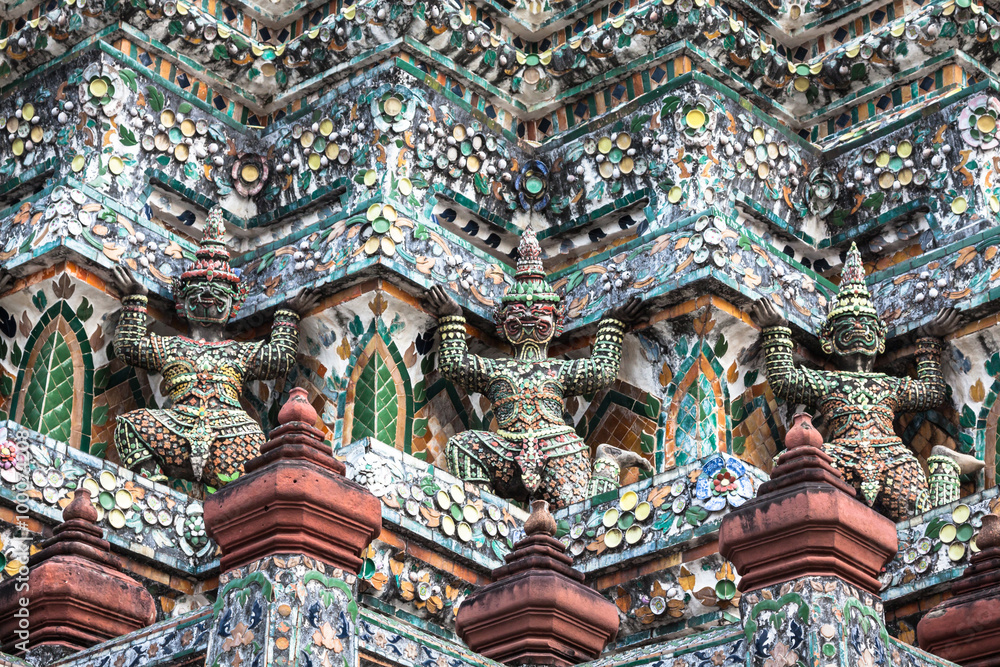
495, 227, 563, 342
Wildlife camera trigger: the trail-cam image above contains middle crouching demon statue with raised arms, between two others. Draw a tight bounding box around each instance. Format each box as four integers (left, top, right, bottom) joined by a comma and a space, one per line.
428, 228, 649, 507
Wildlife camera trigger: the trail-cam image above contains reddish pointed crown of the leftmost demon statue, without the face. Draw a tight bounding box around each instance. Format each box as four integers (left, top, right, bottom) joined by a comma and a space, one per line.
171, 206, 248, 317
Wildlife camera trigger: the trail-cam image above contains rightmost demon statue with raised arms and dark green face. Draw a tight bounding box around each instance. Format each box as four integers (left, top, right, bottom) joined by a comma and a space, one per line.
751, 244, 983, 521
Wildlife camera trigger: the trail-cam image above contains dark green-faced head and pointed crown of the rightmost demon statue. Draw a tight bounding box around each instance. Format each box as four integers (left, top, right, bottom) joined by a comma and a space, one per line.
820, 243, 886, 356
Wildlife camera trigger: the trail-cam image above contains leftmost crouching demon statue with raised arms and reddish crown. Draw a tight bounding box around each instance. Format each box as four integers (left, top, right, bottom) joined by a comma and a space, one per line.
114, 208, 316, 487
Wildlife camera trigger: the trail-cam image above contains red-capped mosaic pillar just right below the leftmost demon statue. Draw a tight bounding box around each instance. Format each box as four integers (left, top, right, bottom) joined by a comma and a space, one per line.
205, 389, 382, 667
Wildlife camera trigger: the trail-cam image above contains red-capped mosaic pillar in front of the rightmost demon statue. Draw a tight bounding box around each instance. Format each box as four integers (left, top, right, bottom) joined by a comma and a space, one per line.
719, 415, 897, 667
